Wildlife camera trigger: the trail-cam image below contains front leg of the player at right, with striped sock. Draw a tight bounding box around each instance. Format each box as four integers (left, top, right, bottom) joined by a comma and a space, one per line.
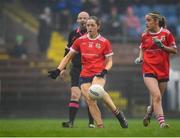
144, 77, 168, 127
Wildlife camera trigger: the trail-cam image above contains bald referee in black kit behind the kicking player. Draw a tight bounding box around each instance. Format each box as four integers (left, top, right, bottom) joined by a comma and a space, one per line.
61, 12, 95, 128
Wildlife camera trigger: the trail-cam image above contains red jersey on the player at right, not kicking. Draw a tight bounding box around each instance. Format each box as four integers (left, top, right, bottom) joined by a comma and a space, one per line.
140, 28, 176, 78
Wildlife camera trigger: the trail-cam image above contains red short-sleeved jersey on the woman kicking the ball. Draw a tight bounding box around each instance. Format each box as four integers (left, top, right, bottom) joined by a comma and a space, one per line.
71, 34, 113, 77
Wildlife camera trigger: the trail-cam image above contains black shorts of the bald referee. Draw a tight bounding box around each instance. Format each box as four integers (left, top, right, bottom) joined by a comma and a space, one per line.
70, 66, 81, 87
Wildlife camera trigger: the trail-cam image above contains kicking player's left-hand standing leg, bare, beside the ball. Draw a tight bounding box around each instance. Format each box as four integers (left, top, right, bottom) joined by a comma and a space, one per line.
81, 79, 103, 128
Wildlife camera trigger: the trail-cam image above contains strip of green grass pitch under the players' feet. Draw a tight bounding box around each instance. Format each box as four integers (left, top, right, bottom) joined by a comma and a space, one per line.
0, 119, 180, 137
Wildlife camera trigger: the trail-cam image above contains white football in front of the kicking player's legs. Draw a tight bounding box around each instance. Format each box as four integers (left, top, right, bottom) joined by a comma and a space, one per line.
89, 84, 105, 100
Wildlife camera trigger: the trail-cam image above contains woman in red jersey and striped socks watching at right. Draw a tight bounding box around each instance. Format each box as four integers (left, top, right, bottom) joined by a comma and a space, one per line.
135, 12, 177, 128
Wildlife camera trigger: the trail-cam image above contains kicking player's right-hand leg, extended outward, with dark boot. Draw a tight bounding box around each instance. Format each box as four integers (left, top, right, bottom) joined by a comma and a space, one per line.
92, 77, 128, 128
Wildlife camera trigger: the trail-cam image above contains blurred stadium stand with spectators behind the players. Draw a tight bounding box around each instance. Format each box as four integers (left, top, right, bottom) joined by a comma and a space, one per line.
0, 0, 180, 118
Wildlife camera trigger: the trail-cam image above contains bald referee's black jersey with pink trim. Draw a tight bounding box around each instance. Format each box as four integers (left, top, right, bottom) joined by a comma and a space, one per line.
64, 28, 87, 67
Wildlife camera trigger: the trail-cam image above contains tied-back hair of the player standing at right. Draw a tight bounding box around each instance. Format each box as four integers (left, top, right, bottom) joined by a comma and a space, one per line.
148, 11, 167, 28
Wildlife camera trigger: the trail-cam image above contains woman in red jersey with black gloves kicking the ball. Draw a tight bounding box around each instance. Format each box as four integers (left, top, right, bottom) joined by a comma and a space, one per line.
49, 16, 128, 128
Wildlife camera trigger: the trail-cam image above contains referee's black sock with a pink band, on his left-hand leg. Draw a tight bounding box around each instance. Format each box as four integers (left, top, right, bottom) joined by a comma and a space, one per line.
69, 101, 79, 124
